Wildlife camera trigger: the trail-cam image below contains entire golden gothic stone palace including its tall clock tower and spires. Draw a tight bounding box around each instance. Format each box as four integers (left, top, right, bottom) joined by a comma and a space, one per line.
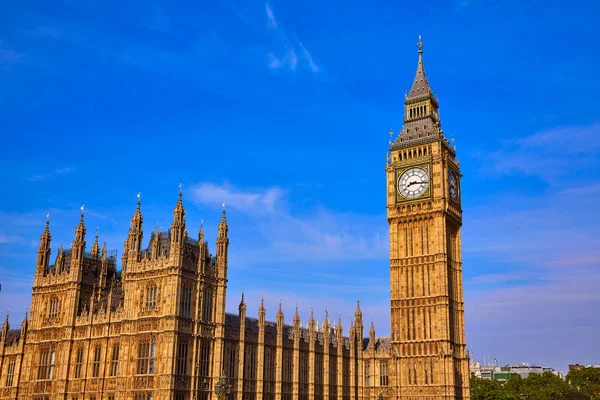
0, 38, 469, 400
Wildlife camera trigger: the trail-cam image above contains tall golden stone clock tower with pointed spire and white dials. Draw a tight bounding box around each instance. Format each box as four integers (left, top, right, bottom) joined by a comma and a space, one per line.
385, 37, 469, 400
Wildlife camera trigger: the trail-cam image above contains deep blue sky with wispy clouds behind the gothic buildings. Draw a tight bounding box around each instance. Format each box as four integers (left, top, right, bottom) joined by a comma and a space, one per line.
0, 0, 600, 370
